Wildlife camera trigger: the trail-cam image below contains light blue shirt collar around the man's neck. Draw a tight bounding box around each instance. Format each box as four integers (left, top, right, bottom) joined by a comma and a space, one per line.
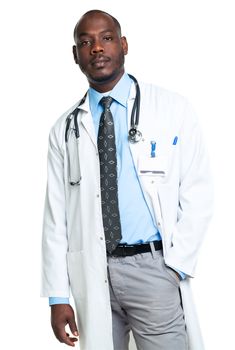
88, 73, 132, 110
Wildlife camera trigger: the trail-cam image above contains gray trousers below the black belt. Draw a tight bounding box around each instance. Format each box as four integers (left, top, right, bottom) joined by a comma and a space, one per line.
108, 248, 188, 350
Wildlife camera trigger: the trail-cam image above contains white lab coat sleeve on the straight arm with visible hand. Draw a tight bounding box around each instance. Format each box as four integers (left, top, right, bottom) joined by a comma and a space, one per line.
41, 127, 69, 298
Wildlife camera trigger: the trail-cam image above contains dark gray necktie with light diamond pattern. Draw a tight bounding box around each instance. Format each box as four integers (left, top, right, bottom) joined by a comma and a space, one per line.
98, 96, 122, 253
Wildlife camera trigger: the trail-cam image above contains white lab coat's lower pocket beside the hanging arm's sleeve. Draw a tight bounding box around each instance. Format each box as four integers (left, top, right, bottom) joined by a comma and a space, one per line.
67, 250, 85, 299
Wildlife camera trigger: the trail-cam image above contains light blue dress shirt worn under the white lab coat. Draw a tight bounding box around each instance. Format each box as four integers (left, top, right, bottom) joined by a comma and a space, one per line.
49, 73, 184, 305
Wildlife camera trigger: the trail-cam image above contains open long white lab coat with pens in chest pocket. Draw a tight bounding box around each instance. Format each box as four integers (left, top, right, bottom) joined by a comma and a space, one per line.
41, 80, 212, 350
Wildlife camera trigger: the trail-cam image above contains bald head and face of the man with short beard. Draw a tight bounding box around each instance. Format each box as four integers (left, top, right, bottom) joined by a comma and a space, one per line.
73, 13, 128, 87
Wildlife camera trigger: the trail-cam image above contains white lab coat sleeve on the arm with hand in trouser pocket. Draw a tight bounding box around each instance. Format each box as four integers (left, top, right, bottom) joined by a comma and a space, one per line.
166, 103, 213, 277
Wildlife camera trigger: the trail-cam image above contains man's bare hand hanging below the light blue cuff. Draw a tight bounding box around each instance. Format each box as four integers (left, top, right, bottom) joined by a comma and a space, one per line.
51, 304, 78, 346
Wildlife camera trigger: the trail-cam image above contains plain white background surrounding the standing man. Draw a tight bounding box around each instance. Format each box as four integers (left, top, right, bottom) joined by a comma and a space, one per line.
0, 0, 235, 350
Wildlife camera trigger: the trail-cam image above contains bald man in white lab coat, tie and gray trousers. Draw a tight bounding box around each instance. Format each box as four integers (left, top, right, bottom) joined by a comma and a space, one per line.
42, 10, 212, 350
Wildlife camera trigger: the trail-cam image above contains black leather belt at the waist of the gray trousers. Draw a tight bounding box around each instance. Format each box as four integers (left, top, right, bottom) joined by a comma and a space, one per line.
107, 241, 162, 257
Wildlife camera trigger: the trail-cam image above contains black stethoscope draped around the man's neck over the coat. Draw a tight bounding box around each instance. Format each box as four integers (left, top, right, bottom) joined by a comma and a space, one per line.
65, 74, 142, 186
